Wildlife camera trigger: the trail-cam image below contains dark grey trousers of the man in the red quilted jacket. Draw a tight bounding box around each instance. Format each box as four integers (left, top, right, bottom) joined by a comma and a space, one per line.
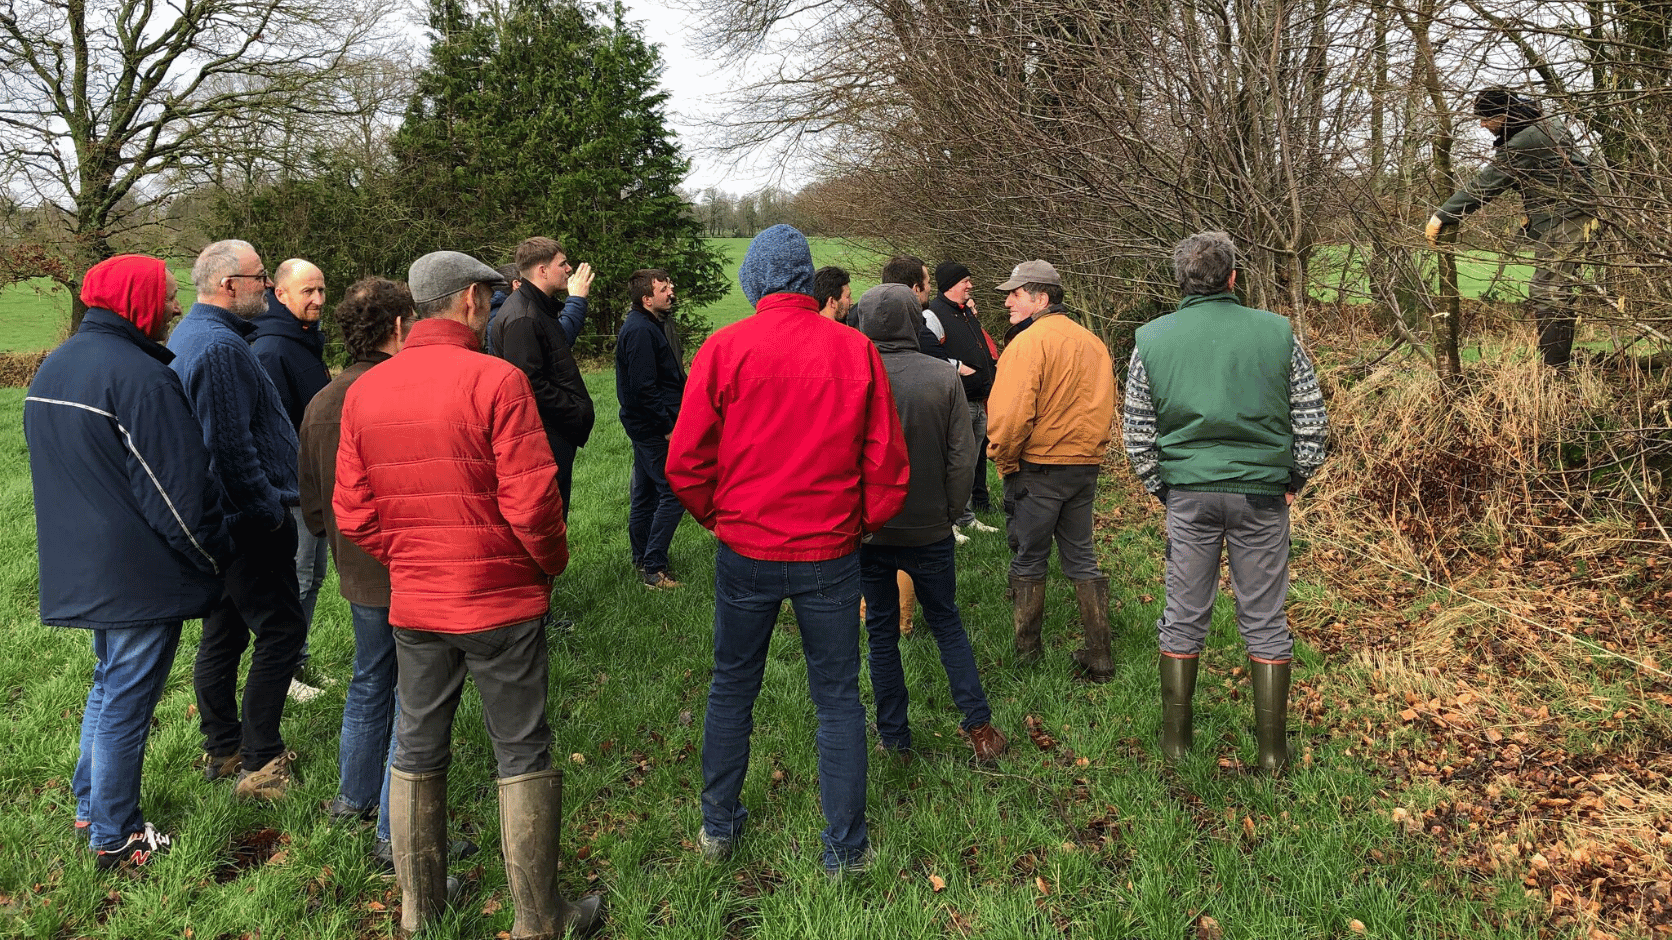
395, 617, 552, 778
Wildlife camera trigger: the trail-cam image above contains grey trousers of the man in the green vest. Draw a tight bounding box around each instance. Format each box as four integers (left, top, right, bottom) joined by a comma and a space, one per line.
1155, 490, 1294, 662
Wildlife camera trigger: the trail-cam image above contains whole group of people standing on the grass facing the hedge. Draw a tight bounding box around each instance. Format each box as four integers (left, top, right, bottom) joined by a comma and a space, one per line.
25, 214, 1326, 938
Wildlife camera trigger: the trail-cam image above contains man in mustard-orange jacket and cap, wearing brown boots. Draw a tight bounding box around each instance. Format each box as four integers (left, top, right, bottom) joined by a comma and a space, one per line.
986, 261, 1115, 682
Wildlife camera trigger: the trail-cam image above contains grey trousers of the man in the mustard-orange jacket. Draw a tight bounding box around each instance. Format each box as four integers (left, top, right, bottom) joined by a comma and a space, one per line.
1005, 462, 1104, 580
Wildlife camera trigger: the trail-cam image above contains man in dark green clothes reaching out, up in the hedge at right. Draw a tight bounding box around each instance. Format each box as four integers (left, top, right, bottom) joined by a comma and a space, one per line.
1425, 89, 1597, 370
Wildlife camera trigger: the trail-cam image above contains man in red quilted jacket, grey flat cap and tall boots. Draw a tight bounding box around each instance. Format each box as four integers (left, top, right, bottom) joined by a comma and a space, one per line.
333, 251, 602, 937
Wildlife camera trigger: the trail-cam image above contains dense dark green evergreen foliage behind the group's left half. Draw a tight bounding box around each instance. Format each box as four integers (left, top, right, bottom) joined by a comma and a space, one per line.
219, 0, 726, 347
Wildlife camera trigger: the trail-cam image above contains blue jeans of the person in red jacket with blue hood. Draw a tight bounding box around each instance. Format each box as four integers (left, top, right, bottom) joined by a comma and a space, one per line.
702, 542, 869, 870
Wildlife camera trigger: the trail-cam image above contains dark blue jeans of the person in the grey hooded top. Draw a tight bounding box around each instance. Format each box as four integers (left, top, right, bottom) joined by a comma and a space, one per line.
859, 535, 993, 751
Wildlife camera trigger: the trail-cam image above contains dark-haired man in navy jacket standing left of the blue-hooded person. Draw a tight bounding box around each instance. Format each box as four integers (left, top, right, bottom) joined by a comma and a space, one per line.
615, 268, 686, 589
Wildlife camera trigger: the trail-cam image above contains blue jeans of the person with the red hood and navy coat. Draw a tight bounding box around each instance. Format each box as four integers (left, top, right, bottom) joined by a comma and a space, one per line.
70, 624, 181, 851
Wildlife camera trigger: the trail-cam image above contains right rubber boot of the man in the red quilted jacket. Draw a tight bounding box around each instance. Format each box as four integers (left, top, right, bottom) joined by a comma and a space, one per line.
501, 768, 604, 940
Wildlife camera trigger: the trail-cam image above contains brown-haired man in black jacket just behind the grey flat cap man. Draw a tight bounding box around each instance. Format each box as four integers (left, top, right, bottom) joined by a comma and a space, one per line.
488, 236, 597, 519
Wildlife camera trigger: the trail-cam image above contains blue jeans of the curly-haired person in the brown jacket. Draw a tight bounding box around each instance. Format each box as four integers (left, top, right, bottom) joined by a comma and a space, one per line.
336, 604, 395, 828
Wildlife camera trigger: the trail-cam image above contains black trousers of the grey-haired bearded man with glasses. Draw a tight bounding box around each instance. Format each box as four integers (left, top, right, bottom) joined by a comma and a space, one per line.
192, 513, 308, 769
